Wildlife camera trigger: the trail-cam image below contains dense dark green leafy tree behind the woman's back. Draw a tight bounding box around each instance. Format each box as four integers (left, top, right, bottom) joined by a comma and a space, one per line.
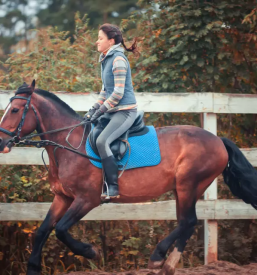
126, 0, 257, 93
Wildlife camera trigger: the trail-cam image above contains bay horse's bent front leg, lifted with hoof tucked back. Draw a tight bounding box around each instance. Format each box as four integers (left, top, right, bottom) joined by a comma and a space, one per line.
55, 197, 100, 259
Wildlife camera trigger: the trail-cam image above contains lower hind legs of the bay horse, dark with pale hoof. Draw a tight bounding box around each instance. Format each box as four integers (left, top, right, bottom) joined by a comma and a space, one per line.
148, 188, 197, 275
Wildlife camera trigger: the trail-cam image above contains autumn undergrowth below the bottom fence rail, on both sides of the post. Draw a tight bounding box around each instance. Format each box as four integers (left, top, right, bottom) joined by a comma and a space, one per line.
0, 216, 257, 275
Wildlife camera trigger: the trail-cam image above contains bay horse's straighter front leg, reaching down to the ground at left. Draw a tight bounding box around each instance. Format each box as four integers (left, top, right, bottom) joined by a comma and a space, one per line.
27, 195, 72, 275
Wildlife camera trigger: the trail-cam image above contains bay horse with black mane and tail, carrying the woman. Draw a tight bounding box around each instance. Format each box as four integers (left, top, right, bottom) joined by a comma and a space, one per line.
0, 80, 257, 275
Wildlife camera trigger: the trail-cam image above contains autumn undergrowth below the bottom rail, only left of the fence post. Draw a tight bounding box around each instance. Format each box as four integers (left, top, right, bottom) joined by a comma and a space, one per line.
0, 221, 203, 275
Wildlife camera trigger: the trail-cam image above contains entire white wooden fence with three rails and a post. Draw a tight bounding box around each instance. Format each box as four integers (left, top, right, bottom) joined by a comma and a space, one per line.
0, 91, 257, 263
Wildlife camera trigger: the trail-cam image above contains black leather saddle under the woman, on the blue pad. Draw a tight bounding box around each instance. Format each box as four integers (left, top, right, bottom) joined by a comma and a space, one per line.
88, 111, 149, 161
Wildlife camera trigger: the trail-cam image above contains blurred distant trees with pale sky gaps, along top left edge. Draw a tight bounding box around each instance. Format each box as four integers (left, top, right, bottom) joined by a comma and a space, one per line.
0, 0, 137, 54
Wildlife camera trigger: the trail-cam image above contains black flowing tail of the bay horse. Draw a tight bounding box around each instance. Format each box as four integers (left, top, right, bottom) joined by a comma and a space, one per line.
221, 138, 257, 209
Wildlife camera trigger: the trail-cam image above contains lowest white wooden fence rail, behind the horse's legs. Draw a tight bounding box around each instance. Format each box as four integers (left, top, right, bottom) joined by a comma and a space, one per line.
0, 200, 257, 221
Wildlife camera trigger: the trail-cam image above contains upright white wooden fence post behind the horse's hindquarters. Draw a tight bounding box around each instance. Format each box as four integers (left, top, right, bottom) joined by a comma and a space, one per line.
203, 113, 218, 264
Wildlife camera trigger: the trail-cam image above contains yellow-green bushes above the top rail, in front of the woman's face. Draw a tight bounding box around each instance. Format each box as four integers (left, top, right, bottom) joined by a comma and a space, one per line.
0, 13, 100, 92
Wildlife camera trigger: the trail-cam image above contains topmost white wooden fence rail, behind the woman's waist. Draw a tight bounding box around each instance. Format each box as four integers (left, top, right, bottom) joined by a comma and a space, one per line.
0, 90, 257, 114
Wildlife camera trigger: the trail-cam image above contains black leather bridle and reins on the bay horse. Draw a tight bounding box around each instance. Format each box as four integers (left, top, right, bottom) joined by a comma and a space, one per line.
0, 90, 101, 167
